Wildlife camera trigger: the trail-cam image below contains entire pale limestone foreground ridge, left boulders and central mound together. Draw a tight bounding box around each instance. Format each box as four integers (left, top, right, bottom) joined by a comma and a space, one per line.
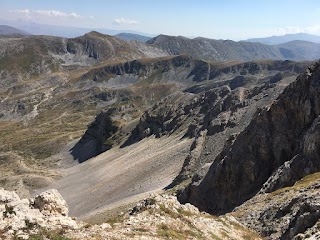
0, 189, 261, 240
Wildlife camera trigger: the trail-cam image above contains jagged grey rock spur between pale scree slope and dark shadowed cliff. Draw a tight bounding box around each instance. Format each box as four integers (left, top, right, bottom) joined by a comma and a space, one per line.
123, 61, 304, 183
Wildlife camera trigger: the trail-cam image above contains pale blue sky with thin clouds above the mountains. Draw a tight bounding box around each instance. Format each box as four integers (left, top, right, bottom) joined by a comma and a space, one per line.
0, 0, 320, 40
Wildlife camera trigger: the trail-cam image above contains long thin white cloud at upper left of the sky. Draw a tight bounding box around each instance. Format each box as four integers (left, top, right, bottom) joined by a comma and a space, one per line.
9, 9, 80, 18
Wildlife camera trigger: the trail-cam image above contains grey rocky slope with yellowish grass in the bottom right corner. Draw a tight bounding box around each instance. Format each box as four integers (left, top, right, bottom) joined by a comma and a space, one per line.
233, 172, 320, 240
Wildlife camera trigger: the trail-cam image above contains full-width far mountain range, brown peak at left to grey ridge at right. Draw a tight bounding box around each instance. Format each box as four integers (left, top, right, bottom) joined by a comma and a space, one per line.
0, 31, 320, 74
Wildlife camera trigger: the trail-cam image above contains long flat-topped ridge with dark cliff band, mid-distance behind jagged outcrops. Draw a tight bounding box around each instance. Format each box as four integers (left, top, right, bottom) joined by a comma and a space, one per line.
82, 55, 310, 89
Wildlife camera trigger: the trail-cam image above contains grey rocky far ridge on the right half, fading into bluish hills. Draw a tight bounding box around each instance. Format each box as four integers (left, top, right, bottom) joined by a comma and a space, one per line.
147, 35, 320, 61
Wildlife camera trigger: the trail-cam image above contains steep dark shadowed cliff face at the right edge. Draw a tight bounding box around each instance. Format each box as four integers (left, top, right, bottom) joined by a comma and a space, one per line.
180, 63, 320, 214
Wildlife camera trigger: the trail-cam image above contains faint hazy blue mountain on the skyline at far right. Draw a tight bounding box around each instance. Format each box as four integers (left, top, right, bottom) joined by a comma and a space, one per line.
245, 33, 320, 45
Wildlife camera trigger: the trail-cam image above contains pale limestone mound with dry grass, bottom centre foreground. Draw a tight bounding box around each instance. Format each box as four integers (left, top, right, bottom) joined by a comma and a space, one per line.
66, 194, 262, 240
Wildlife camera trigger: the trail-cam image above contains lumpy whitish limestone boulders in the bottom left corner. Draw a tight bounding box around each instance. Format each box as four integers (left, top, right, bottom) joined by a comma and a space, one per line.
0, 188, 81, 239
